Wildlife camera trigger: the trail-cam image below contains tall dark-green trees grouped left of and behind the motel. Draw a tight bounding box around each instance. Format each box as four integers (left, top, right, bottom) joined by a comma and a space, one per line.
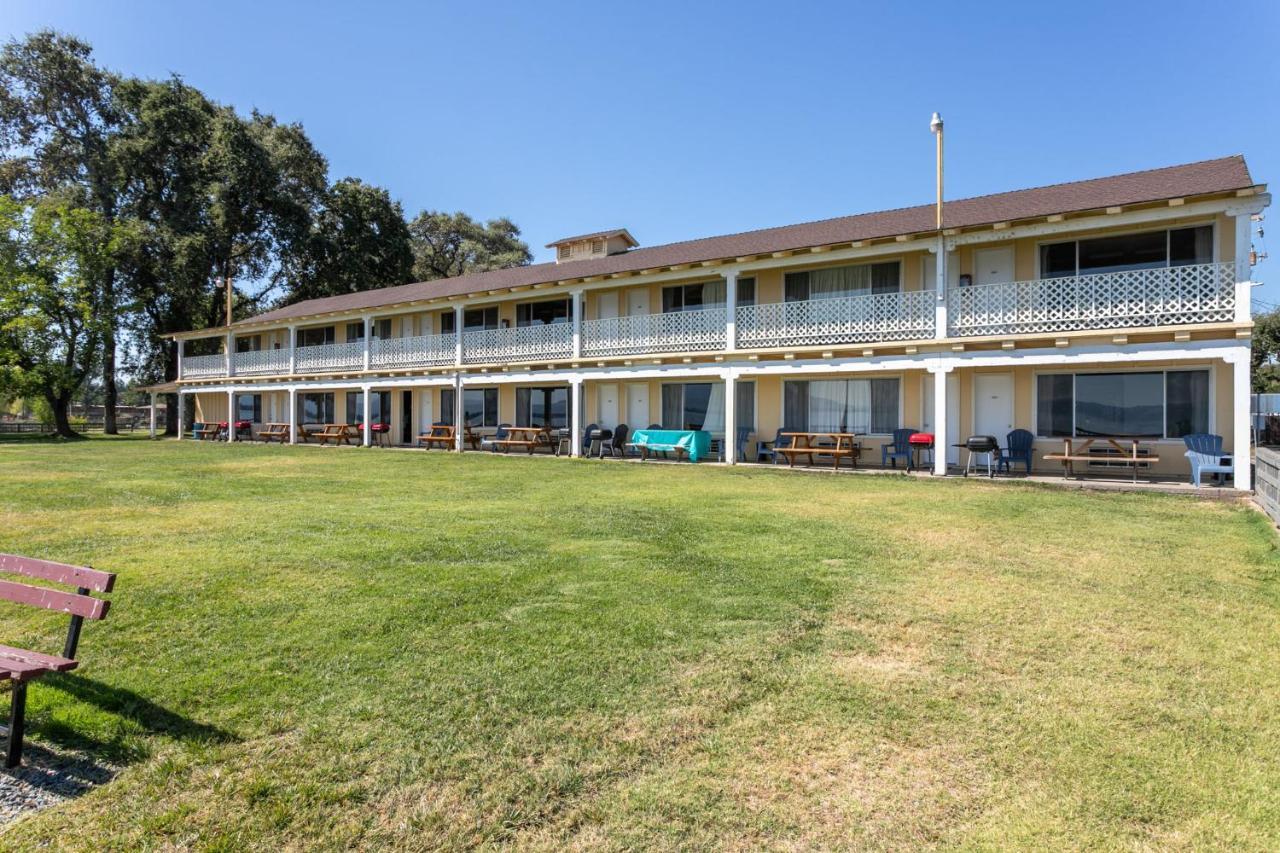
0, 31, 532, 437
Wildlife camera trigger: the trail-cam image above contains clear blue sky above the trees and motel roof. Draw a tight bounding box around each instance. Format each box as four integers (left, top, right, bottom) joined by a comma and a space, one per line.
0, 0, 1280, 302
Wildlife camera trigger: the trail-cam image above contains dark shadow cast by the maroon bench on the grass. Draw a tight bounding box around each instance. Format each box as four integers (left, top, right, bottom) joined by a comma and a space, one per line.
33, 672, 238, 763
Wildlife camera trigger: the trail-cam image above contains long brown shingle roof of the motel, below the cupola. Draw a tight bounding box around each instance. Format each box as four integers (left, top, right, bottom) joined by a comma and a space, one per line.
237, 155, 1254, 325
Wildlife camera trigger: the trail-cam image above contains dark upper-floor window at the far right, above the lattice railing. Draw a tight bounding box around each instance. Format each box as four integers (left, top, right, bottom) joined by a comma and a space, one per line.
1041, 225, 1213, 278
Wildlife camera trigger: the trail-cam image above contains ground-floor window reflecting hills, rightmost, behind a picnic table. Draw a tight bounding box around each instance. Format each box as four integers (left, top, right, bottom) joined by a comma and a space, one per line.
1036, 370, 1210, 438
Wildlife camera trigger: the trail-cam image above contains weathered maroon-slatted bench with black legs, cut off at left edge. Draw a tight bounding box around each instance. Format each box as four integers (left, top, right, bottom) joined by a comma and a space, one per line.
0, 553, 115, 767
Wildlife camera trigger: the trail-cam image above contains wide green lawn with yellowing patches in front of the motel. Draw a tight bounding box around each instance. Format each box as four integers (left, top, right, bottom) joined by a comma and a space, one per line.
0, 439, 1280, 849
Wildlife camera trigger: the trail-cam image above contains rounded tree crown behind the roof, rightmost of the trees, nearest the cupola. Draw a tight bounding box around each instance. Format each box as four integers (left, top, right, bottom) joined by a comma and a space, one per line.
408, 210, 532, 282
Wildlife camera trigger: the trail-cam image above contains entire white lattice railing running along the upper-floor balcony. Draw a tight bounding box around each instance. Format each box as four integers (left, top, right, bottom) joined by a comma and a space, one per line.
180, 263, 1249, 379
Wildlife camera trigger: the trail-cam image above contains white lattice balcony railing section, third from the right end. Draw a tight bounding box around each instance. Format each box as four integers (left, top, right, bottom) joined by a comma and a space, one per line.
582, 306, 726, 356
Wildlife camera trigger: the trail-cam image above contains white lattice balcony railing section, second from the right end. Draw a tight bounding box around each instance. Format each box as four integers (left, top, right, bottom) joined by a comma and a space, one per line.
737, 291, 934, 348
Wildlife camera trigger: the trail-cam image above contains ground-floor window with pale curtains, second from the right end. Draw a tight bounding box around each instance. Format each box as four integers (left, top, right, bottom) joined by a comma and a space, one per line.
782, 378, 901, 434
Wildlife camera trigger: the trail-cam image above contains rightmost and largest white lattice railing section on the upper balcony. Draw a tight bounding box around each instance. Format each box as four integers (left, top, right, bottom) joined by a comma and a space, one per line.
947, 264, 1235, 337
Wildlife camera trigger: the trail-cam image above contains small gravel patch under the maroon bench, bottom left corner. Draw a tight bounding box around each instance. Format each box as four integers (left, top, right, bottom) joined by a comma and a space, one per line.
0, 742, 119, 827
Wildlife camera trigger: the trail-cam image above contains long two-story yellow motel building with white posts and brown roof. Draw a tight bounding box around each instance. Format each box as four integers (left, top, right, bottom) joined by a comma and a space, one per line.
175, 156, 1270, 489
